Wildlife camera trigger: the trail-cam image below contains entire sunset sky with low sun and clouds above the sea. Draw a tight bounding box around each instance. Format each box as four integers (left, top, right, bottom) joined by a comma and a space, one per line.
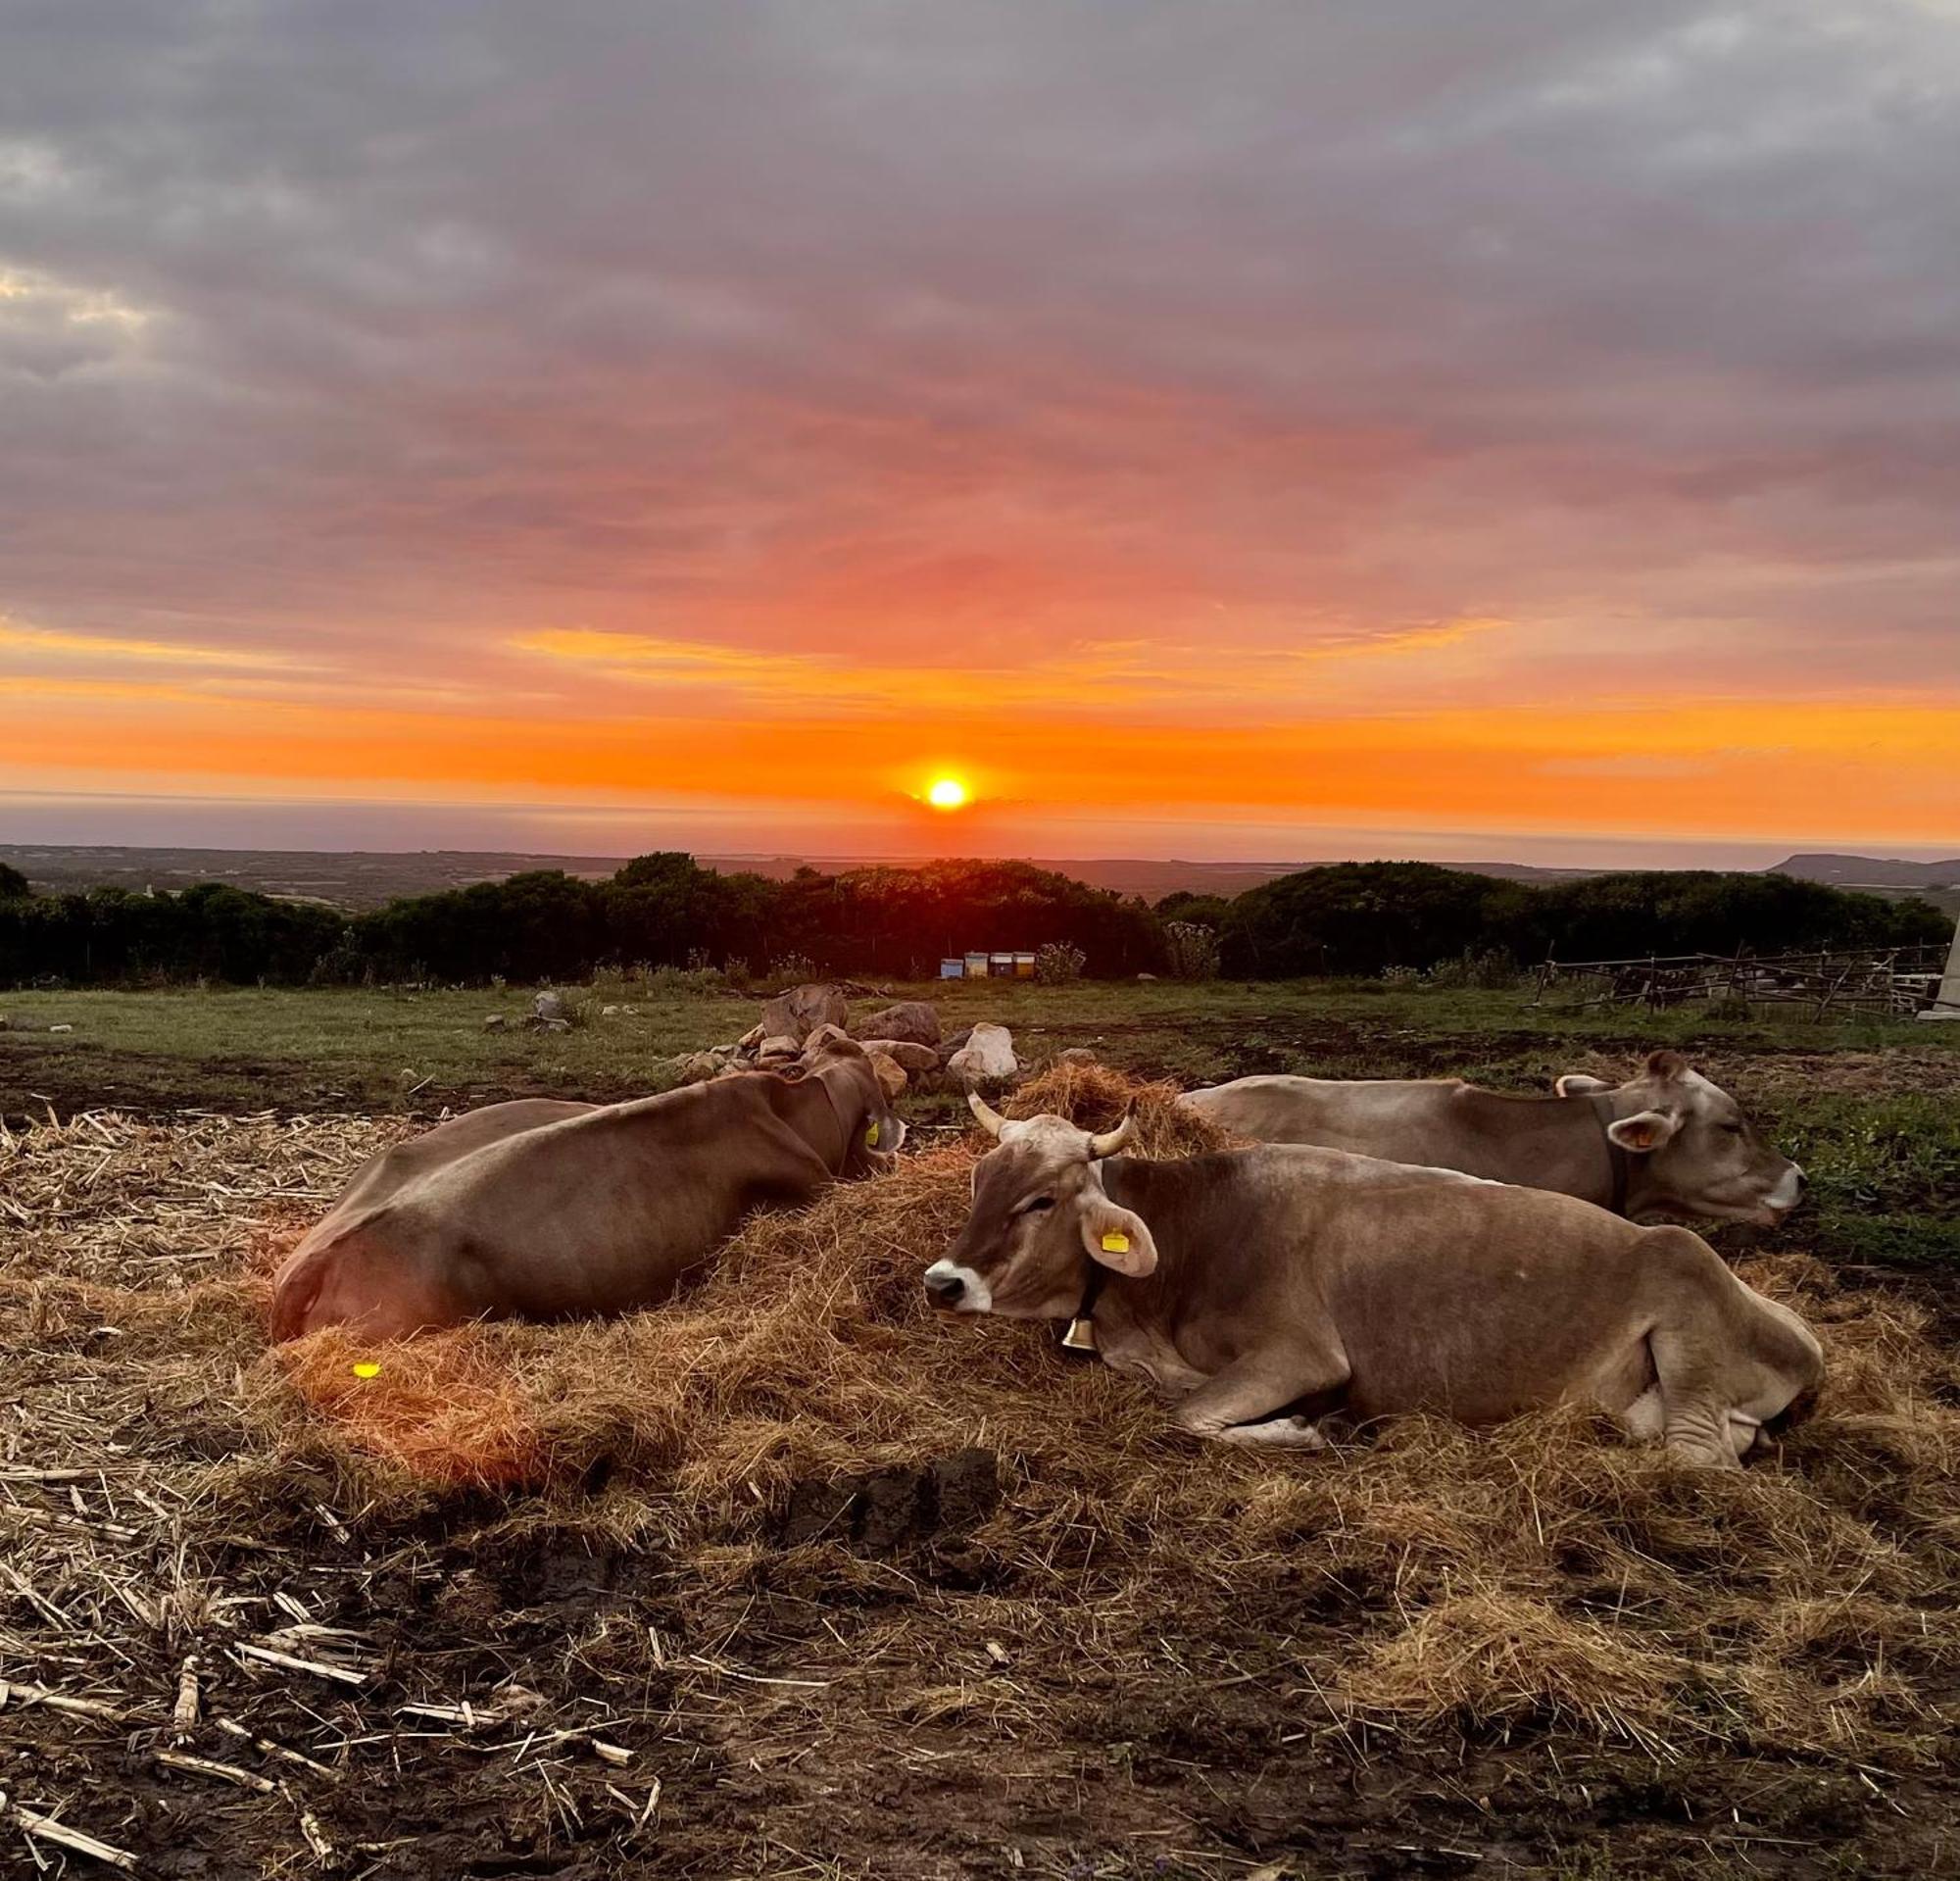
0, 0, 1960, 859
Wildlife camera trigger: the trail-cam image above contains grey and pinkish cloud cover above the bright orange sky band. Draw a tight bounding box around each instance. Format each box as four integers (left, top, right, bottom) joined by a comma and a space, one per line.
0, 0, 1960, 680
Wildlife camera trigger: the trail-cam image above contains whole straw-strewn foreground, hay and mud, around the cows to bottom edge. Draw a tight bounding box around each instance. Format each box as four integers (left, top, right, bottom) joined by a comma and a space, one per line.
0, 1071, 1960, 1881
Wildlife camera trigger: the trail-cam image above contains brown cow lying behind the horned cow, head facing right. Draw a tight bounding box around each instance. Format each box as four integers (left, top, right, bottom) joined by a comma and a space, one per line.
1184, 1052, 1803, 1226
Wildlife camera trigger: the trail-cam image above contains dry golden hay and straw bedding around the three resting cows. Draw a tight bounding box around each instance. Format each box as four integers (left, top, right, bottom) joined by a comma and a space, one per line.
0, 1067, 1960, 1818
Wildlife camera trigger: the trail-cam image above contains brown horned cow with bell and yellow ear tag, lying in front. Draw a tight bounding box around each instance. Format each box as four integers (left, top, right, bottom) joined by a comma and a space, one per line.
925, 1099, 1823, 1467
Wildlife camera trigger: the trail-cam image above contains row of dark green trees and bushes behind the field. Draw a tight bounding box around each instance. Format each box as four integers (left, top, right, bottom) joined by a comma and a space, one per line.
0, 853, 1952, 985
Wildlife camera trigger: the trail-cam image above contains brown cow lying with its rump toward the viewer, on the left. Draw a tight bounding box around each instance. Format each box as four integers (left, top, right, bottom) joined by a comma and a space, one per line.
272, 1038, 906, 1338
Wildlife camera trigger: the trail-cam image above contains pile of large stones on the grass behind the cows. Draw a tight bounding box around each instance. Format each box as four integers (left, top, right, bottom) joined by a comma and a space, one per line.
680, 983, 1021, 1097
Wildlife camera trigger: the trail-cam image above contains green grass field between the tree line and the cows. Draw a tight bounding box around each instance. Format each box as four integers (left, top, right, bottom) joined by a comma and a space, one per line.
0, 979, 1960, 1265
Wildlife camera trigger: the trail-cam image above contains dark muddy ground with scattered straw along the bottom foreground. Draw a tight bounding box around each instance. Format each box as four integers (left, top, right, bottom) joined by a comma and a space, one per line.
19, 1524, 1960, 1881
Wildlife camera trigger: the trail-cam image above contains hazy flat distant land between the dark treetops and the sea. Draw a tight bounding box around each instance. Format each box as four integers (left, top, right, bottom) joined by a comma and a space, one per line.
0, 843, 1599, 912
